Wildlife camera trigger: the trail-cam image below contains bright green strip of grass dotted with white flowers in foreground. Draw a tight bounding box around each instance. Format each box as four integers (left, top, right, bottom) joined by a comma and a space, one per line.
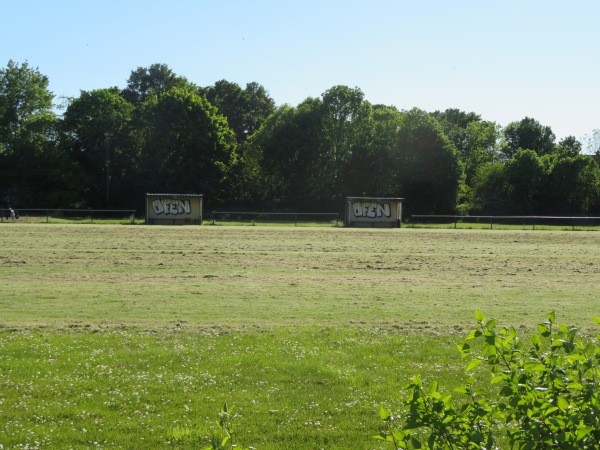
0, 329, 466, 449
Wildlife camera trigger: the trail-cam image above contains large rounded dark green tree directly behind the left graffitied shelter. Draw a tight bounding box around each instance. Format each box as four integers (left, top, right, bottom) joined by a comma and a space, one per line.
139, 87, 237, 204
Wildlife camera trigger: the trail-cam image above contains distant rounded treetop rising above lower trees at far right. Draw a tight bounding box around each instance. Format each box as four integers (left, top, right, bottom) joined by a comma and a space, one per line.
504, 117, 556, 159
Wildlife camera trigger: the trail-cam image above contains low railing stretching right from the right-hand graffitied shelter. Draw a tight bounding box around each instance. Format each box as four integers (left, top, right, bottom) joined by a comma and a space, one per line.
410, 214, 600, 230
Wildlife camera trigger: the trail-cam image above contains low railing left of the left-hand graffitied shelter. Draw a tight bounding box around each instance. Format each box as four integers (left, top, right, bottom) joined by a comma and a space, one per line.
0, 209, 135, 223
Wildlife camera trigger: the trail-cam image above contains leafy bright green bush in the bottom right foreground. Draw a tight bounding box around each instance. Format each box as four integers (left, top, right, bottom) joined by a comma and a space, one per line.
375, 311, 600, 450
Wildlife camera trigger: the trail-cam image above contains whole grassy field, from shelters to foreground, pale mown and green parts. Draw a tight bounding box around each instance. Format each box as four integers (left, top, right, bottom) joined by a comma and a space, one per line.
0, 223, 600, 449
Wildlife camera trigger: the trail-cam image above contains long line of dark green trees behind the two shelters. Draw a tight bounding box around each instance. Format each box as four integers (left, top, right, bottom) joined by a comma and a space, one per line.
0, 61, 600, 215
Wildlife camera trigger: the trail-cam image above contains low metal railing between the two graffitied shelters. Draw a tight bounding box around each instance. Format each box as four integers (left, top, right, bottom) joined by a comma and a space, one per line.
207, 211, 341, 226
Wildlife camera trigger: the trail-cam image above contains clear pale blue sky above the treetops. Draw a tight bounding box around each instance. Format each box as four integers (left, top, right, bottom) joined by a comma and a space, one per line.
0, 0, 600, 138
